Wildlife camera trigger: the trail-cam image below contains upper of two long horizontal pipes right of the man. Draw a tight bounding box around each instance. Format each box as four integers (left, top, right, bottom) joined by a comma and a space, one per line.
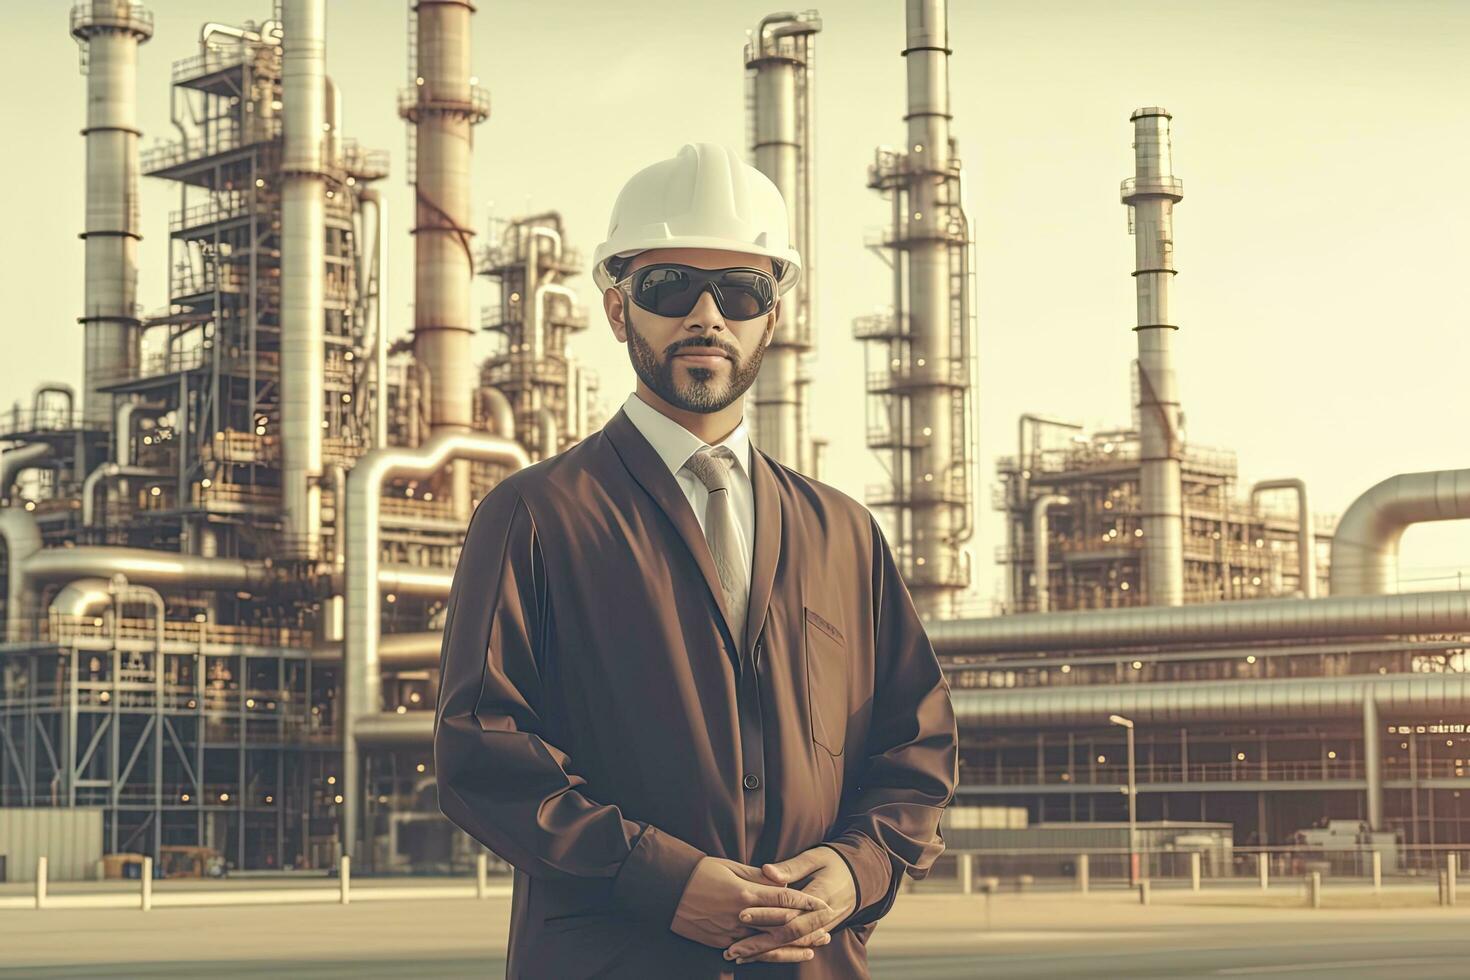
925, 591, 1470, 654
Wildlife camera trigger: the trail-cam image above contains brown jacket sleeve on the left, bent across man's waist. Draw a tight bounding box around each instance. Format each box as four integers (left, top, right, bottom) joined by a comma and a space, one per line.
434, 482, 704, 926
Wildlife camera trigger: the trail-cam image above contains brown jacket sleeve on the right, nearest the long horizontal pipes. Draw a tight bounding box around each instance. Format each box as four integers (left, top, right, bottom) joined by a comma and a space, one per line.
822, 514, 960, 929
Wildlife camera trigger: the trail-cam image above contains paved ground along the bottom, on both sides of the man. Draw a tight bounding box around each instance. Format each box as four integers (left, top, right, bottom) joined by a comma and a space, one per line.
0, 889, 1470, 980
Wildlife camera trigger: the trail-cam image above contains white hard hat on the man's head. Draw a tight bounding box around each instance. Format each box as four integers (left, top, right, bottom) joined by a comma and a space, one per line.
592, 143, 801, 292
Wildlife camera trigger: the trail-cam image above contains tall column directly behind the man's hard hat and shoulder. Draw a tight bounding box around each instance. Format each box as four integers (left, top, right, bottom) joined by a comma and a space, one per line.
745, 12, 822, 475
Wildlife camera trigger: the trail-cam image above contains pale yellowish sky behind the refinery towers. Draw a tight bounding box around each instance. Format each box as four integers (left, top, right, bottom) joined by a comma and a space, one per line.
0, 0, 1470, 611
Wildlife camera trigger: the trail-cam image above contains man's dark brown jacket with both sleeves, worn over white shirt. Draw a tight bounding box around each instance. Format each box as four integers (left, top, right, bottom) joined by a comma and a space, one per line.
434, 402, 958, 980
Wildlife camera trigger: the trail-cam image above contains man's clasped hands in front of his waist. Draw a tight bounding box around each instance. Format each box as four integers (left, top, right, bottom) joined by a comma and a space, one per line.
670, 846, 857, 962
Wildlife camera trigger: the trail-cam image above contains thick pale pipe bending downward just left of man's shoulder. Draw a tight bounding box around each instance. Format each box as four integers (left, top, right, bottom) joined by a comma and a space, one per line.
341, 432, 531, 858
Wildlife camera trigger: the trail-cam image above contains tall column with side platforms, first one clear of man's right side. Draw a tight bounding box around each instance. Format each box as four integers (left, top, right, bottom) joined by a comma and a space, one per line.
854, 0, 975, 619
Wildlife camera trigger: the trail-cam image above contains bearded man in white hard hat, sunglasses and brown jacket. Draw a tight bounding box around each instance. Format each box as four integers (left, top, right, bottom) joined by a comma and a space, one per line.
434, 144, 957, 980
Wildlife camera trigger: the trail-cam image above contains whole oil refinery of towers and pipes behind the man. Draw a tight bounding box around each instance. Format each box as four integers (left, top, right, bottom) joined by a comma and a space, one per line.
0, 0, 1470, 871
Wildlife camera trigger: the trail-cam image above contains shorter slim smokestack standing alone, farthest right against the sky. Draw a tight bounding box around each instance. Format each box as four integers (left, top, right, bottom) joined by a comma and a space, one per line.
1123, 106, 1185, 605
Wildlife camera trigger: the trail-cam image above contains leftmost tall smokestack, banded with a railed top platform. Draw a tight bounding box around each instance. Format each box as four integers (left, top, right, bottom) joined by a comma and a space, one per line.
71, 0, 153, 429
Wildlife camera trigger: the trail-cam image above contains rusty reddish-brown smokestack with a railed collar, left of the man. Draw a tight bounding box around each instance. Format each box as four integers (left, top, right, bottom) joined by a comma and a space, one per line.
400, 0, 490, 519
